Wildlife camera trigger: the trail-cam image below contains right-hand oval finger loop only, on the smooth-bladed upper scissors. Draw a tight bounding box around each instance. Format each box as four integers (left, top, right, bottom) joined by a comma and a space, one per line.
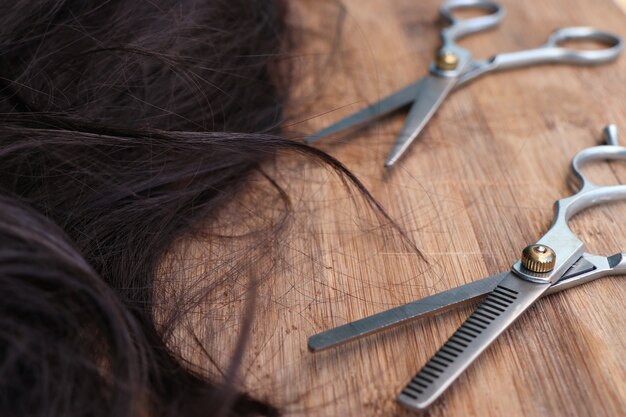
543, 26, 624, 64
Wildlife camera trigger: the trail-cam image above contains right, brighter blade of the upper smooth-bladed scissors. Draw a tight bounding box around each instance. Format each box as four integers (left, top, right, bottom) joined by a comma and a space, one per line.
385, 75, 457, 167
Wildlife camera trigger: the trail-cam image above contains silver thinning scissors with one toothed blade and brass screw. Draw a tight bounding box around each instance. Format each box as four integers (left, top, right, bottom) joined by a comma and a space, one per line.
308, 125, 626, 410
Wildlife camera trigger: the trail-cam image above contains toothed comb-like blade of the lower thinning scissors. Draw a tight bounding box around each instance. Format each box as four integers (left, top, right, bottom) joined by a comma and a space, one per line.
398, 272, 550, 410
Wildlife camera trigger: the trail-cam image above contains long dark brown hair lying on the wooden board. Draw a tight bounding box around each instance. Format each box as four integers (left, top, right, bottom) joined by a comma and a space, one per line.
0, 0, 392, 416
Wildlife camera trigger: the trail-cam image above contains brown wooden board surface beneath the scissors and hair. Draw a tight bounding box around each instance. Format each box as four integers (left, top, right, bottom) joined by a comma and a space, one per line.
193, 0, 626, 417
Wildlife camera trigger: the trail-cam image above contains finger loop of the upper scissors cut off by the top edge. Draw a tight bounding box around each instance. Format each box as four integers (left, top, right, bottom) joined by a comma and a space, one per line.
439, 0, 504, 46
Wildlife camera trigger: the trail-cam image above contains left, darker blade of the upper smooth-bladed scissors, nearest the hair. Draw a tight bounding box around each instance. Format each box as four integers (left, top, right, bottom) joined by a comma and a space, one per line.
304, 80, 422, 143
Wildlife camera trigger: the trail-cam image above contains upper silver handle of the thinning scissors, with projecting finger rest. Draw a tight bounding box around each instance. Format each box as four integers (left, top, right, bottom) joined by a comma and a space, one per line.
514, 125, 626, 282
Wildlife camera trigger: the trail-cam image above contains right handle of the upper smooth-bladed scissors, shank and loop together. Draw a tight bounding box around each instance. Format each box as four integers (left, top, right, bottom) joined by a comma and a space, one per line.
488, 27, 624, 70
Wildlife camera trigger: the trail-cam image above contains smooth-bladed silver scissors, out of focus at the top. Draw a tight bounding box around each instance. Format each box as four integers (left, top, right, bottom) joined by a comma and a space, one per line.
305, 0, 623, 167
